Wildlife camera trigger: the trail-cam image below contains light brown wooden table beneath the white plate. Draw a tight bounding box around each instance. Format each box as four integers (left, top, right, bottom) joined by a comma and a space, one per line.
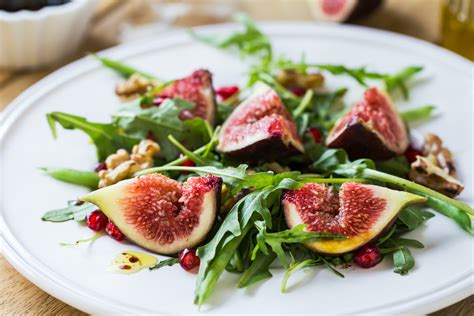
0, 0, 474, 316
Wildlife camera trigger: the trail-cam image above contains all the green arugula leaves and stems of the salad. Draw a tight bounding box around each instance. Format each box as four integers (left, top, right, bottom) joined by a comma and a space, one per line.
43, 15, 474, 305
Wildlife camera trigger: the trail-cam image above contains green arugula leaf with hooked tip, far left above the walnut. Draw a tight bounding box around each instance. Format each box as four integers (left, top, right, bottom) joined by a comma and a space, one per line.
46, 112, 140, 161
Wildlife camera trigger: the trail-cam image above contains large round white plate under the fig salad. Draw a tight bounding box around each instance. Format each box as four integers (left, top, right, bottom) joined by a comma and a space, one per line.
0, 23, 474, 314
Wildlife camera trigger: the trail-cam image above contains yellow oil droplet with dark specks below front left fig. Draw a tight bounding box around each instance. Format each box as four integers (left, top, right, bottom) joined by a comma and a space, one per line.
110, 251, 158, 274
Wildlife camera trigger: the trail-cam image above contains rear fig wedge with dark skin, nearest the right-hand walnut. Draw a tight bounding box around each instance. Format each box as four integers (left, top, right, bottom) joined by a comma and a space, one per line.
326, 88, 409, 159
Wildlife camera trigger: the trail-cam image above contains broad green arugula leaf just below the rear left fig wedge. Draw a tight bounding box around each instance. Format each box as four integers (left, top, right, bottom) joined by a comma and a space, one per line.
113, 99, 209, 161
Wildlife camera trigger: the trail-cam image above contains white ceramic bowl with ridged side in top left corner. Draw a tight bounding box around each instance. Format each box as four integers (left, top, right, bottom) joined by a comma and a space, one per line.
0, 0, 97, 69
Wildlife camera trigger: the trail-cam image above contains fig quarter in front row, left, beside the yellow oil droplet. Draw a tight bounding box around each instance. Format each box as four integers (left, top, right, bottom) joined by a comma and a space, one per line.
82, 174, 222, 254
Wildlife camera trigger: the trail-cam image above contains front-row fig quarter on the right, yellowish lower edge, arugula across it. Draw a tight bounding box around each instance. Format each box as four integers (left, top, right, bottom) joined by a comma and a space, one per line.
282, 182, 426, 254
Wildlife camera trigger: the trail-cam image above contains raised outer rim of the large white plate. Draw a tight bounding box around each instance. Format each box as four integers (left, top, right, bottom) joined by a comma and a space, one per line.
0, 21, 474, 313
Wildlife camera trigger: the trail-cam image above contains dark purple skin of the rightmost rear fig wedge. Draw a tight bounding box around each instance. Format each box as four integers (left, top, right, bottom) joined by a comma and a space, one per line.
327, 116, 397, 160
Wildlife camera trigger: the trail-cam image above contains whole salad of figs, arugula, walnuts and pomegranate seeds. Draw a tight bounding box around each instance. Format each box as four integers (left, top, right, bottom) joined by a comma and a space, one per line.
42, 15, 474, 306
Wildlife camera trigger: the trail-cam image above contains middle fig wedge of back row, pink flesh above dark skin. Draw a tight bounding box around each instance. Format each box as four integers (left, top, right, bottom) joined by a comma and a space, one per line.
217, 83, 304, 161
